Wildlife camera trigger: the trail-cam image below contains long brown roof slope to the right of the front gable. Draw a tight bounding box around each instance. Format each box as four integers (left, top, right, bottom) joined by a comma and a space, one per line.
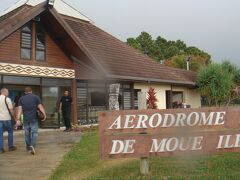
62, 16, 196, 85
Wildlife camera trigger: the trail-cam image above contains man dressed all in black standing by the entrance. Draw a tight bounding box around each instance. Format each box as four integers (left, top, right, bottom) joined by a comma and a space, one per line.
59, 91, 72, 131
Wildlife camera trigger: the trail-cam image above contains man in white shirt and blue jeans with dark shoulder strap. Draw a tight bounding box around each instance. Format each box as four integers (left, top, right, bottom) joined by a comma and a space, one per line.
0, 88, 17, 154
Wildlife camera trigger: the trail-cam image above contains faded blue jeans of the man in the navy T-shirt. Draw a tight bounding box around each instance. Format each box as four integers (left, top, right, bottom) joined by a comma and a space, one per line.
23, 120, 38, 150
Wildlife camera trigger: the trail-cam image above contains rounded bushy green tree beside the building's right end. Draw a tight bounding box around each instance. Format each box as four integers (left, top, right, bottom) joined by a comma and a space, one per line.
196, 63, 234, 106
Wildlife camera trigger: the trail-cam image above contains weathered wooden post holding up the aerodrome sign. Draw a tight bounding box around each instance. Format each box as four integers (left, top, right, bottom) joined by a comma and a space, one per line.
138, 92, 149, 175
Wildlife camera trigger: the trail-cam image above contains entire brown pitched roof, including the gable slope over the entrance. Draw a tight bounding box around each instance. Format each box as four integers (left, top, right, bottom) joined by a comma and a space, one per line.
0, 3, 196, 85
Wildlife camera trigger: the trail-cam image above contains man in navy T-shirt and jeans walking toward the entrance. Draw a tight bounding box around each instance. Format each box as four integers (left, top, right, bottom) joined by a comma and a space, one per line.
17, 87, 46, 155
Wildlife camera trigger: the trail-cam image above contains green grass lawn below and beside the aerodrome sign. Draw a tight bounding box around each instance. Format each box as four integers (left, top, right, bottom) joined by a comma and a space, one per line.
50, 132, 240, 180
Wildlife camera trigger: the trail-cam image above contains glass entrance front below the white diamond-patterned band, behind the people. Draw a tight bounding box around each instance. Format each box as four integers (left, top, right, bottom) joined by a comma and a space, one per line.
0, 75, 72, 128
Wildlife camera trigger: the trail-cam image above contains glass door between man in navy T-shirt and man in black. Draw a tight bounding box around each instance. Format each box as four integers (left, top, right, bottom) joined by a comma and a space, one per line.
41, 87, 60, 128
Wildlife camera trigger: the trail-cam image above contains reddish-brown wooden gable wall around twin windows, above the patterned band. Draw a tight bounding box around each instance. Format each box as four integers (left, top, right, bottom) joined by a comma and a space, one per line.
0, 23, 74, 69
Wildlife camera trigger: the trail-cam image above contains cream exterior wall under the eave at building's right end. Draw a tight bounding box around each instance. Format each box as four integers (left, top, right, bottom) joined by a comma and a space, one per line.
134, 83, 201, 109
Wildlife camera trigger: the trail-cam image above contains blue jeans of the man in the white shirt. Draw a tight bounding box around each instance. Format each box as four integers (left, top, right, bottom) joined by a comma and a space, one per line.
0, 120, 13, 151
